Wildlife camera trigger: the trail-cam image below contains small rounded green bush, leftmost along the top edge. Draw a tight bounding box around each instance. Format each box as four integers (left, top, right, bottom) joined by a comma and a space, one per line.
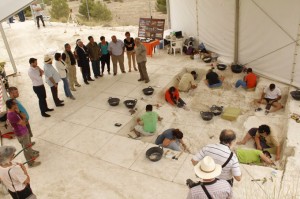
50, 0, 70, 19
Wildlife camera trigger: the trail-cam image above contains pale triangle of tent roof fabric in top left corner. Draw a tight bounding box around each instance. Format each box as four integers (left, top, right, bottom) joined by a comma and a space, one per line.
0, 0, 33, 22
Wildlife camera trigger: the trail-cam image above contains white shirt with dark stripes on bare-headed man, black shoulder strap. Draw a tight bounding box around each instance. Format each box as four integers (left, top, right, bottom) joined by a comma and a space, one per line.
193, 144, 242, 180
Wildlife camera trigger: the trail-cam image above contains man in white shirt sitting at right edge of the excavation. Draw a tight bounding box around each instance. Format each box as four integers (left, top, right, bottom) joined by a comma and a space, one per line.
256, 84, 283, 115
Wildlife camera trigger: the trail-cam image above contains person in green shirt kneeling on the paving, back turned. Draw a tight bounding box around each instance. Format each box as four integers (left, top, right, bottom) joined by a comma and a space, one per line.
128, 104, 163, 139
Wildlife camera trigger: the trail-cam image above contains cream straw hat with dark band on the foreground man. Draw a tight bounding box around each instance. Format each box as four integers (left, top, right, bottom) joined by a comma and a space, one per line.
194, 156, 222, 179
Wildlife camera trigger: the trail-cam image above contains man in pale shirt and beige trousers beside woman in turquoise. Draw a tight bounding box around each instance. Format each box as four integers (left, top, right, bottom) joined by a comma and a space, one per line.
108, 35, 126, 75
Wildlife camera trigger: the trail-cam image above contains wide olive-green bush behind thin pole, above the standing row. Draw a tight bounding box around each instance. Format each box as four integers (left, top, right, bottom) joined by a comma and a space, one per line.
79, 0, 112, 21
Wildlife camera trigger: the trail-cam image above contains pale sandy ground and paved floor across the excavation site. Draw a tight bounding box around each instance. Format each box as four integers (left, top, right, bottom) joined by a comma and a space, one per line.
0, 21, 299, 198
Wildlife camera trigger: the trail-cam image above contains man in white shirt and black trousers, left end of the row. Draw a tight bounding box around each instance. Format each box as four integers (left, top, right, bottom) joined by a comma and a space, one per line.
28, 58, 54, 117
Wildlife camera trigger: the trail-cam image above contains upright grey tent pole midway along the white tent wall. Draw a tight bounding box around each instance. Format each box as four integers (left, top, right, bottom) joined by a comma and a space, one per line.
233, 0, 240, 64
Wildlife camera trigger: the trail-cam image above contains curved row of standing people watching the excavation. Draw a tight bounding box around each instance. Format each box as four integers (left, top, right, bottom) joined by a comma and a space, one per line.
28, 32, 150, 117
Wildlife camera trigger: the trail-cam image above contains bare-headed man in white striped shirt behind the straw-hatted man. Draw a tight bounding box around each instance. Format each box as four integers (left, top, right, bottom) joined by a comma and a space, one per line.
192, 129, 242, 186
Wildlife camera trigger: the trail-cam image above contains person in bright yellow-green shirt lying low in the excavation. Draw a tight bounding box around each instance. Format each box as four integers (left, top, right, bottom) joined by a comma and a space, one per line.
235, 149, 274, 165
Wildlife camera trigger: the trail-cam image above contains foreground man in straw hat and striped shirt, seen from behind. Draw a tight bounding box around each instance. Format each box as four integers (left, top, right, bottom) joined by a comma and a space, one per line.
187, 156, 232, 199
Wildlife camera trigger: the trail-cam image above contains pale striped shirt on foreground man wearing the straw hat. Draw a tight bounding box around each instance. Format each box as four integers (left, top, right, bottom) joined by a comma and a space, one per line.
187, 180, 232, 199
